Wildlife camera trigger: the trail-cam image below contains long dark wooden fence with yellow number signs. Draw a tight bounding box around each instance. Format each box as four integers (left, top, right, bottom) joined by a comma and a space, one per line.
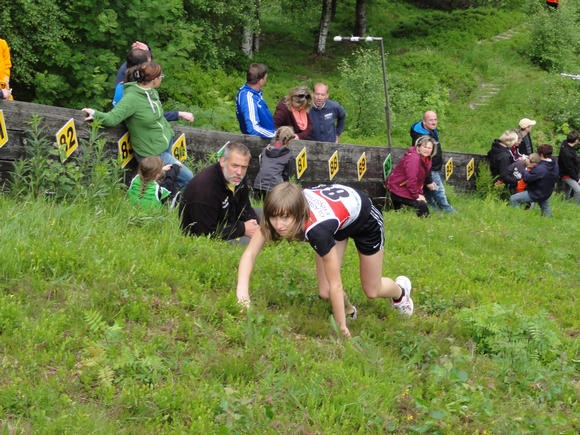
0, 101, 485, 202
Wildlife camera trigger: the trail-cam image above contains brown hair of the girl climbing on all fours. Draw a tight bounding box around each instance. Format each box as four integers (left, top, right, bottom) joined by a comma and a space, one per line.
260, 182, 310, 242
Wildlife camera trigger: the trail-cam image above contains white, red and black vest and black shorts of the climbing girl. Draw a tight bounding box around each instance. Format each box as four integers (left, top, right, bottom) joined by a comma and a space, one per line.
304, 184, 384, 256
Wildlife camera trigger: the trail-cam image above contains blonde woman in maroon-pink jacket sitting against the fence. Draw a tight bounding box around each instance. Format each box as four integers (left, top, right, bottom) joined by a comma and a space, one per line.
386, 136, 437, 217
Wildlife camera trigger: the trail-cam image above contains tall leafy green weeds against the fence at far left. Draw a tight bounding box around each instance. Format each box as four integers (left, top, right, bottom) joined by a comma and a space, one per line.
11, 116, 122, 200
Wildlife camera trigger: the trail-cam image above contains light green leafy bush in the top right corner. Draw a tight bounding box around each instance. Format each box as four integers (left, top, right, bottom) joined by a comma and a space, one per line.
528, 2, 580, 72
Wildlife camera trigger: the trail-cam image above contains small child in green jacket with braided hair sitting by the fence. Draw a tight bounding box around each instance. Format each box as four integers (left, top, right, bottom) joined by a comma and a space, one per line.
127, 156, 179, 209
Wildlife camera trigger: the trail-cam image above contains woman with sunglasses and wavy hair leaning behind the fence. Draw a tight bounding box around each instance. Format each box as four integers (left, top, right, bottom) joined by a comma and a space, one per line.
274, 86, 312, 139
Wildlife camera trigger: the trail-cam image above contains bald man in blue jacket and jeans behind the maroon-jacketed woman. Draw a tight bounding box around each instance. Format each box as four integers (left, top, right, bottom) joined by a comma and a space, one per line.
409, 110, 455, 213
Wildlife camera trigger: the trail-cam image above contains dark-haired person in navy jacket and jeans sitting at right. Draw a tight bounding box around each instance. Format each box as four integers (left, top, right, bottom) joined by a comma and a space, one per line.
510, 144, 559, 217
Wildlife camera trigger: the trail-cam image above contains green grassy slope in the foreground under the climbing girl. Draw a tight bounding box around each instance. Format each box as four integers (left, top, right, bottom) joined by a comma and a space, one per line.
0, 191, 580, 433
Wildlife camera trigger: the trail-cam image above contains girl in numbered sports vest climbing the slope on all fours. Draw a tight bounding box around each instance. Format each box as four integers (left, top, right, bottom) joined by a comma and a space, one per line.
236, 182, 413, 337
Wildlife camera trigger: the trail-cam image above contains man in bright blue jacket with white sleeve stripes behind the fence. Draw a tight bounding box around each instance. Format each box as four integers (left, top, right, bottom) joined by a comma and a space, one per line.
236, 63, 276, 139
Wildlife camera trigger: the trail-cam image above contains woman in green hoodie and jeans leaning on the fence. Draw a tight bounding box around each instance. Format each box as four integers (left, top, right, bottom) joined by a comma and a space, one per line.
83, 61, 193, 189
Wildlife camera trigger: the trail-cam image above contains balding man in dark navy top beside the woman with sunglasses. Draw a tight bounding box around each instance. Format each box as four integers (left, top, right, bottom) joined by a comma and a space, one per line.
309, 83, 346, 143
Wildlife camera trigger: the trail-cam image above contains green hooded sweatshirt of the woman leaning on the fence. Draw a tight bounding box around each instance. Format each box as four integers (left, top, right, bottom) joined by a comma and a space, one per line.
94, 82, 174, 157
